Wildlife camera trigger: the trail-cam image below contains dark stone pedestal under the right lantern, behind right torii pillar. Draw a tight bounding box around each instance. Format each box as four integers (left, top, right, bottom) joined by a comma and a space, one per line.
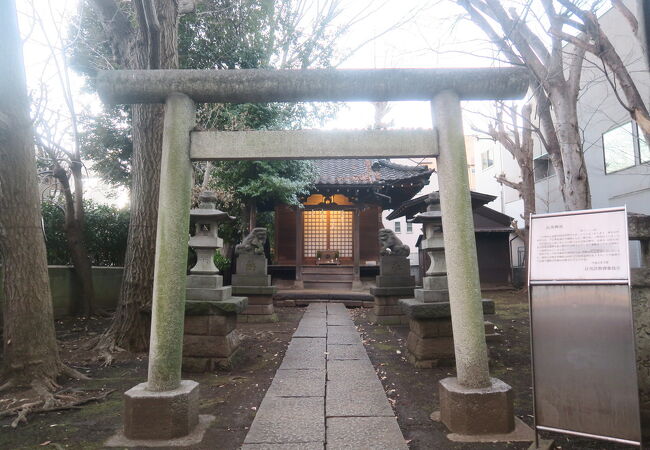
399, 298, 494, 368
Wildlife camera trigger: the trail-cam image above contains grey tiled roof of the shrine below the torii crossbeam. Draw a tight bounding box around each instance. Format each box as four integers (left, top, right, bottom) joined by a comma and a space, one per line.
313, 159, 433, 186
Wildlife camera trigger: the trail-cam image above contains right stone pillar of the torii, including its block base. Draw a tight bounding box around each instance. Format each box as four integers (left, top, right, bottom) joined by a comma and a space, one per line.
431, 91, 514, 434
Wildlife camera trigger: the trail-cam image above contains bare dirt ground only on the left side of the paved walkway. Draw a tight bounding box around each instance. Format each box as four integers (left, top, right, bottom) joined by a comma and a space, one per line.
0, 308, 304, 450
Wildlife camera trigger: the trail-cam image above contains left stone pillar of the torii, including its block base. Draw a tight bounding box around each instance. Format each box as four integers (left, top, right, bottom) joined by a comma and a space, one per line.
124, 93, 205, 440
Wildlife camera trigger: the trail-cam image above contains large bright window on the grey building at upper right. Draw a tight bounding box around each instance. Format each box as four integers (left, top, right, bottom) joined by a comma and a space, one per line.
603, 122, 650, 173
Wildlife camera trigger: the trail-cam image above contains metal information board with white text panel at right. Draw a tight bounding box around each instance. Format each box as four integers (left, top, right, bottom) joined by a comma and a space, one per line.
528, 208, 641, 445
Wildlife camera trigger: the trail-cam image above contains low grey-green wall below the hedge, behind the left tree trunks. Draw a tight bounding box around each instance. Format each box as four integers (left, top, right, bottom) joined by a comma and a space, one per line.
0, 266, 124, 319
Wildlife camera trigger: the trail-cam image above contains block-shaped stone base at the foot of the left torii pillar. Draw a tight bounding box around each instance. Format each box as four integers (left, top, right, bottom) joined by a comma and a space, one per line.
124, 380, 199, 440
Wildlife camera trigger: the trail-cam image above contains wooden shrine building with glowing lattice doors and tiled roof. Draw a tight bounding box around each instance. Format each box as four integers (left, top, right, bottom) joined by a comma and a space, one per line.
271, 159, 432, 289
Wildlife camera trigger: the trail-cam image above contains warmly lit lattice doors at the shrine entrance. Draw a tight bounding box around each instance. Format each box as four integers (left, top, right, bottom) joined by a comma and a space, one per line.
304, 211, 352, 258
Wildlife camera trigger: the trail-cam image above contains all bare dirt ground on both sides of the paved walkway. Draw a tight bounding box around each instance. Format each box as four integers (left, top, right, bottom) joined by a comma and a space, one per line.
0, 291, 631, 450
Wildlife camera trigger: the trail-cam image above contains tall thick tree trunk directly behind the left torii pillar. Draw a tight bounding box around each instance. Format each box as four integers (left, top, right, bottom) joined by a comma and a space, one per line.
95, 1, 180, 351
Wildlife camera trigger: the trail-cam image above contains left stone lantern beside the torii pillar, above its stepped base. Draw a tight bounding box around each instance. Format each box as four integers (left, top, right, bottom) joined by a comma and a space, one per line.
190, 191, 229, 275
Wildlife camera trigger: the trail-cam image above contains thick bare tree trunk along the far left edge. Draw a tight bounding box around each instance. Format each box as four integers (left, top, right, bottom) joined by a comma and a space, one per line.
0, 1, 64, 389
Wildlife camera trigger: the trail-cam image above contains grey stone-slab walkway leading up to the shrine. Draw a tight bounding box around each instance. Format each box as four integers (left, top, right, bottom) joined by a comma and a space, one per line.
242, 303, 407, 450
